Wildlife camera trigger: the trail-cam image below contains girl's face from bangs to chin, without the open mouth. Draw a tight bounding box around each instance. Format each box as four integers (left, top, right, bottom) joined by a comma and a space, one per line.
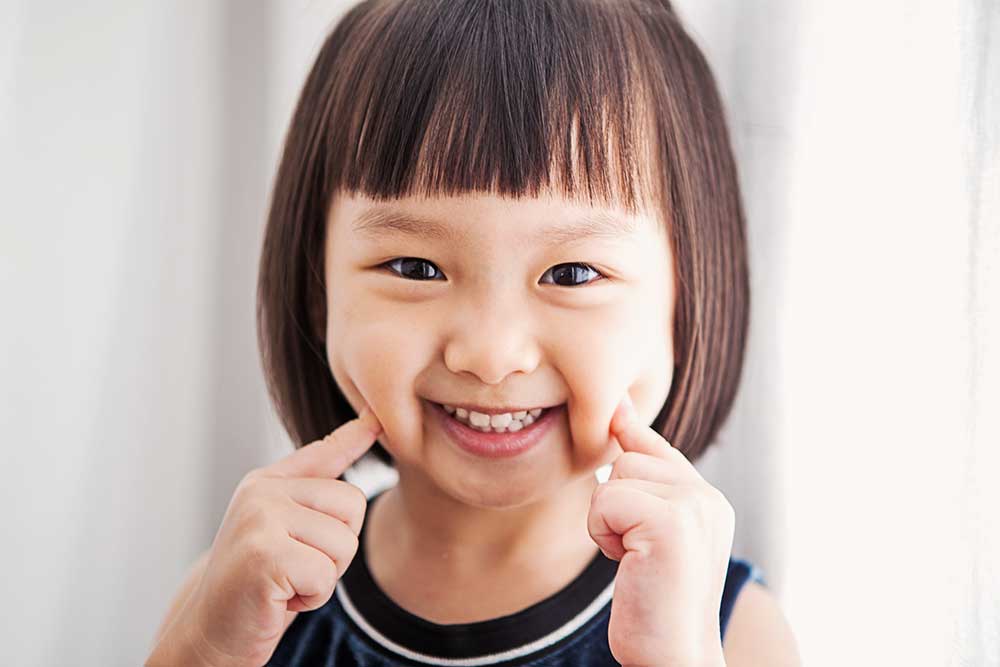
325, 193, 674, 507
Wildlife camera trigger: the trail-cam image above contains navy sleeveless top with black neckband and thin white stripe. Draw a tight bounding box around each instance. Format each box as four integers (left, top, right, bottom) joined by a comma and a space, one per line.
265, 492, 766, 667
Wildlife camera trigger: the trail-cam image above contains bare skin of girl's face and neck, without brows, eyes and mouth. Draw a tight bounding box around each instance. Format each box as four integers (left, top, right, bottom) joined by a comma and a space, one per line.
324, 187, 675, 623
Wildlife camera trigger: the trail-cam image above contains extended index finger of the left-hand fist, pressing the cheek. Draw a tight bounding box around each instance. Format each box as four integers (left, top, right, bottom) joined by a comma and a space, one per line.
267, 406, 382, 479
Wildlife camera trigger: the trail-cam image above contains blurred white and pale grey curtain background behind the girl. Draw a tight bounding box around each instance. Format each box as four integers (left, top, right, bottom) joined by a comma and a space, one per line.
0, 0, 1000, 666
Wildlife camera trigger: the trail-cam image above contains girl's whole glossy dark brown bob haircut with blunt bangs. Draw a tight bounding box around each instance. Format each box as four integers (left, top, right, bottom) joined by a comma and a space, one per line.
257, 0, 750, 474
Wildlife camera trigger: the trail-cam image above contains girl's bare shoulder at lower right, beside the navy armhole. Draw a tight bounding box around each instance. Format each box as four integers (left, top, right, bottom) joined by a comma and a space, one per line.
722, 580, 802, 667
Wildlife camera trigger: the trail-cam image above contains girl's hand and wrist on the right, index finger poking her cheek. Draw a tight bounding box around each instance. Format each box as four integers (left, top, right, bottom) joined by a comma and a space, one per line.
587, 394, 736, 667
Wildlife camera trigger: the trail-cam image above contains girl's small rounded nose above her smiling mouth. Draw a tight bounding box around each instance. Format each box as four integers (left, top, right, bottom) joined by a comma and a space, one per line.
444, 291, 541, 385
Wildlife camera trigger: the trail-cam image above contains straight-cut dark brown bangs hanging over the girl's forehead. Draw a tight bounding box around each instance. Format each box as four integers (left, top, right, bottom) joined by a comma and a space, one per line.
317, 0, 662, 213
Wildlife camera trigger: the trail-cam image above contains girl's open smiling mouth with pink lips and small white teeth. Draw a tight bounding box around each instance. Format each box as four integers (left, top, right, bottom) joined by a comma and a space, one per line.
425, 401, 565, 459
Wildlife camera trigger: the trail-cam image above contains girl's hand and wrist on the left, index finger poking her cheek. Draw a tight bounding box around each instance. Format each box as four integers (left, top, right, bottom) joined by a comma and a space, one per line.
155, 406, 381, 667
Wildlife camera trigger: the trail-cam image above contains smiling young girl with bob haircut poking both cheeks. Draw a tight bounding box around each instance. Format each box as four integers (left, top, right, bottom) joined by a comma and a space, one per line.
147, 0, 798, 667
